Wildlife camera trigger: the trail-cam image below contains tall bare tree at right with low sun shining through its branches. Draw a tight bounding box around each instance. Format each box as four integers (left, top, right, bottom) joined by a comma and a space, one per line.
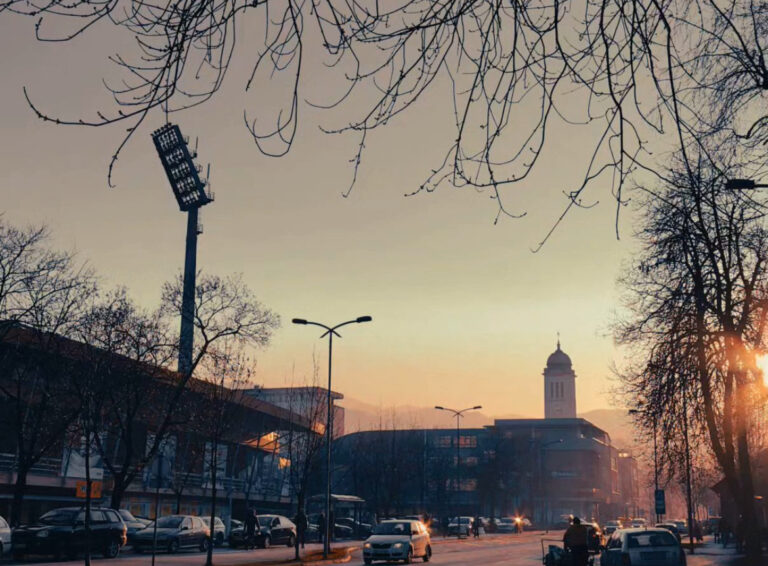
616, 148, 768, 564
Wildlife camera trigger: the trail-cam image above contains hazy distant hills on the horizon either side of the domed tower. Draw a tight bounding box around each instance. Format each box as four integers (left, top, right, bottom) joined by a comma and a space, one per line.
341, 397, 634, 448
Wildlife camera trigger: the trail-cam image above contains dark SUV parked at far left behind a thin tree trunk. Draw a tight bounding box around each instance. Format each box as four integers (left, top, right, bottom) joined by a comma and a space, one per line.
12, 507, 127, 560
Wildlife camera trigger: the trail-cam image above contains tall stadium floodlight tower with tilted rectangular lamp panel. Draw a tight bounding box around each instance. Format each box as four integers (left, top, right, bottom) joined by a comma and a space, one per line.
152, 124, 213, 373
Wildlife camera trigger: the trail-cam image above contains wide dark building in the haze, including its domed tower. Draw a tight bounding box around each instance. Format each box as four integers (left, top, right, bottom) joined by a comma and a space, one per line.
333, 343, 640, 525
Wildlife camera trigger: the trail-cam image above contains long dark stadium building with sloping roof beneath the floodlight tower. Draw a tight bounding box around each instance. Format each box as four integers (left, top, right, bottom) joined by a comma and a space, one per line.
0, 326, 324, 521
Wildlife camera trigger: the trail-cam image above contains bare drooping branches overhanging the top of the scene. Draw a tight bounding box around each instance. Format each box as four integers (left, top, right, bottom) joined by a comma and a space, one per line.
9, 0, 768, 233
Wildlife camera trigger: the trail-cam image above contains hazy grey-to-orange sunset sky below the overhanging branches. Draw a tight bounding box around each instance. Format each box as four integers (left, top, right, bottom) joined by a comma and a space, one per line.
0, 10, 632, 417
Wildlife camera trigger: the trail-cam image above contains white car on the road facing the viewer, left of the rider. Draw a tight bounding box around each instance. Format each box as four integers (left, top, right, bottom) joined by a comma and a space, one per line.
363, 520, 432, 564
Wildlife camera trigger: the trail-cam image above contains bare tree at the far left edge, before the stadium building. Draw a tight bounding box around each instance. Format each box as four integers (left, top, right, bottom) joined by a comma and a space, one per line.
0, 217, 96, 525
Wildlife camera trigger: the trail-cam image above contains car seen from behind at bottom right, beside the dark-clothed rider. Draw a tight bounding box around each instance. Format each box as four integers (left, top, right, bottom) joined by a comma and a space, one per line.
600, 529, 685, 566
